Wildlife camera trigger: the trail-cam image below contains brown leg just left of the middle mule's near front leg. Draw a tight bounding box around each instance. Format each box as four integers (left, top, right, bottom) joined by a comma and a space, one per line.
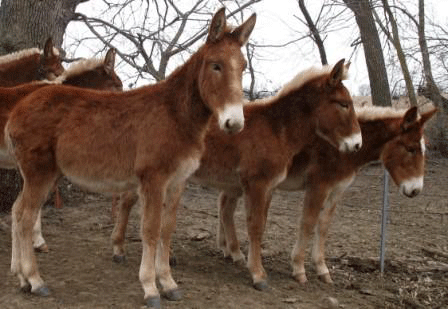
217, 191, 246, 263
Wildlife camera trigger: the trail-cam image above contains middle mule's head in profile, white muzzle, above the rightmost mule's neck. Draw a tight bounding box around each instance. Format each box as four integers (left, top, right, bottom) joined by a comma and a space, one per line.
310, 59, 362, 152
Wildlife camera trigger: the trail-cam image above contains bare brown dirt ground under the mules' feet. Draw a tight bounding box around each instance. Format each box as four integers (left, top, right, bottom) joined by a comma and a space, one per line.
0, 157, 448, 309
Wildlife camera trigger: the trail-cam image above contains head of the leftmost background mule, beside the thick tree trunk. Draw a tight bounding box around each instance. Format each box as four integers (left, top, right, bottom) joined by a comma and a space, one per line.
38, 38, 64, 81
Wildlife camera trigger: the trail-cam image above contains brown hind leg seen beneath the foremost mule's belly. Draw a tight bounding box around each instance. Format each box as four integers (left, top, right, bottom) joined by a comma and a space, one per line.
111, 191, 138, 263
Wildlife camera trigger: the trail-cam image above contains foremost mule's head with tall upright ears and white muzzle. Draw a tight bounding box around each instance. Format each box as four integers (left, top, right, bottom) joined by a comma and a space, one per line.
198, 8, 256, 133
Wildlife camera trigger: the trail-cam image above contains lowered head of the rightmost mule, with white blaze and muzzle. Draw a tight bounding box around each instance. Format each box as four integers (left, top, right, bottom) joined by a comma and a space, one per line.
381, 107, 437, 197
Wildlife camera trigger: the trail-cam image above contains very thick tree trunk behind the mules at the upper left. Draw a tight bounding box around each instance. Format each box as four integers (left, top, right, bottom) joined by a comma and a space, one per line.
0, 0, 88, 55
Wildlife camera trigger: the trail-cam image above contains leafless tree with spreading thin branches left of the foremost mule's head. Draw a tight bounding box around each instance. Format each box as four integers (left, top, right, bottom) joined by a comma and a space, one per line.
69, 0, 261, 86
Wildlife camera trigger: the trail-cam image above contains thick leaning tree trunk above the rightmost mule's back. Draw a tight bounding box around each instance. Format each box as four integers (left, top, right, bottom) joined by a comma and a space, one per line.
344, 0, 392, 106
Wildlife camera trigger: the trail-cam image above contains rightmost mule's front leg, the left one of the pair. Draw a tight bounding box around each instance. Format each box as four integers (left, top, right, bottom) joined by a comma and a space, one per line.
291, 187, 328, 284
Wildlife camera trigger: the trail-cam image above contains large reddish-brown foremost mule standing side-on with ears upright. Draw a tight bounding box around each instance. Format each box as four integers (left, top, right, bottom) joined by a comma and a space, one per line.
5, 9, 256, 308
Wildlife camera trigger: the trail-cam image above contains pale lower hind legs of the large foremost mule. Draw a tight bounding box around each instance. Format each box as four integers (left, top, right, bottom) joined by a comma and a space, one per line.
11, 175, 56, 296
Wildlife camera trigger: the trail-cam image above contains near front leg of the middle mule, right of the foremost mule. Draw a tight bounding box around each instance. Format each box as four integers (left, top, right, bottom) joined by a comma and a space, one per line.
245, 182, 271, 291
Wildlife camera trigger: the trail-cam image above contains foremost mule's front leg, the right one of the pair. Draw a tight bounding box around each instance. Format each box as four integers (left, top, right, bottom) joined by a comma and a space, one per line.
156, 183, 185, 300
